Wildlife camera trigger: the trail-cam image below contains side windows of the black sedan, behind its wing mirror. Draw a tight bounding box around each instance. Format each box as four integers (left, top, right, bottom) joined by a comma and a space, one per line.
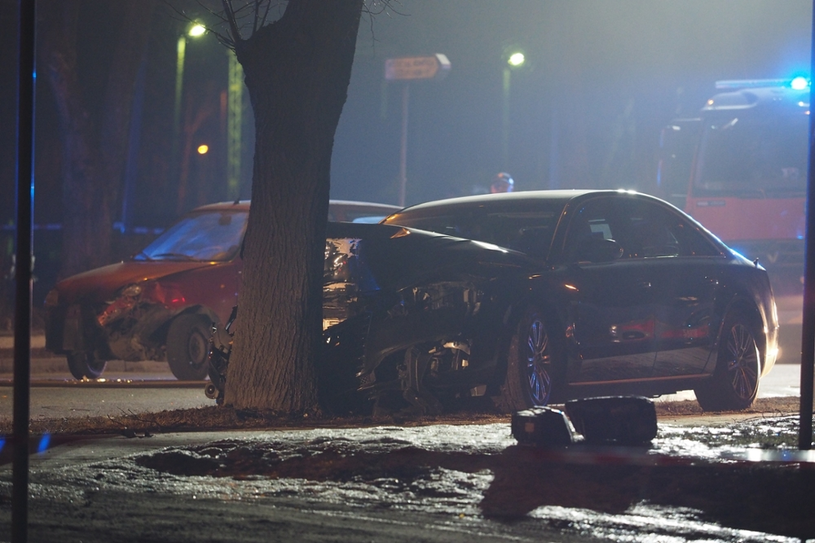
564, 198, 719, 262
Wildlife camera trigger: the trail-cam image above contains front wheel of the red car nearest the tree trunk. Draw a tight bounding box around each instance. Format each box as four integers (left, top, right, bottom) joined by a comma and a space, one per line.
167, 314, 211, 381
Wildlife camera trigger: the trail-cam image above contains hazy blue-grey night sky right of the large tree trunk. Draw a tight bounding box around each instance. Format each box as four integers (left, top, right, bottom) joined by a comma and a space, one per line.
332, 0, 811, 203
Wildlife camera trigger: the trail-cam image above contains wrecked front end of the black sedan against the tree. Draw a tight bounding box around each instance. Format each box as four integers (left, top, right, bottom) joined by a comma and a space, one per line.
318, 225, 519, 412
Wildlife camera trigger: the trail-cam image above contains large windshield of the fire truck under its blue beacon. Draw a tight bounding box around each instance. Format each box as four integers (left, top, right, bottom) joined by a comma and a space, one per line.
693, 115, 809, 198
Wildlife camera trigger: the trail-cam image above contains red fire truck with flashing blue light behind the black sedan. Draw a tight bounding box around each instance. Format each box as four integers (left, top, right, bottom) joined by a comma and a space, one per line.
657, 77, 810, 294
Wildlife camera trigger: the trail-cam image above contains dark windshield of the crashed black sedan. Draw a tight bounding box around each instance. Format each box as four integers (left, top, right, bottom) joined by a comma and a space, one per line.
385, 206, 563, 259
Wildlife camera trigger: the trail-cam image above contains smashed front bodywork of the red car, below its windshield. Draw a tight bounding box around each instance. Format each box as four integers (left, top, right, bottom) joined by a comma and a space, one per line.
46, 259, 240, 379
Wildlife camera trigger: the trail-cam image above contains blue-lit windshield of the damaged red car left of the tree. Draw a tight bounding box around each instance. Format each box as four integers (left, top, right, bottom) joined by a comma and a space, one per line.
134, 211, 249, 261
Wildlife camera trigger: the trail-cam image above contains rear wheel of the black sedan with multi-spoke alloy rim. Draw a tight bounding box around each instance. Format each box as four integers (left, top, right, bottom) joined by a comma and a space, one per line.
694, 312, 761, 411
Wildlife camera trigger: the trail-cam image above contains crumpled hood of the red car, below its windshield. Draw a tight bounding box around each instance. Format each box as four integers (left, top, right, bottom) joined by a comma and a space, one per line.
56, 260, 216, 304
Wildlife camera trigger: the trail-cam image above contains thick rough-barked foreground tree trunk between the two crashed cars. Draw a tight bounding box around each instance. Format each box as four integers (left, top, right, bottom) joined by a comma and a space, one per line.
225, 0, 363, 413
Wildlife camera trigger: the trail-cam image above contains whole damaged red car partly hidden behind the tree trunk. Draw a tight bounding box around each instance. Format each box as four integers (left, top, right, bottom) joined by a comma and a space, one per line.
45, 200, 400, 380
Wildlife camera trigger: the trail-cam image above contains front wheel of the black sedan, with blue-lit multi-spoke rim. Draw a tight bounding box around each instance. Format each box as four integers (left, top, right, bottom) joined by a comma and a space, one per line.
498, 308, 555, 412
